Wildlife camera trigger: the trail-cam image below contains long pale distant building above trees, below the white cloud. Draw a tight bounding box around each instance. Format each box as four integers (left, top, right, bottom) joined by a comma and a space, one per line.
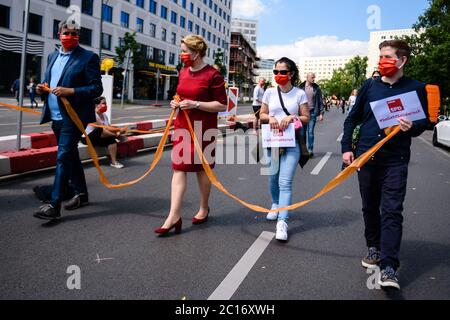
299, 56, 362, 81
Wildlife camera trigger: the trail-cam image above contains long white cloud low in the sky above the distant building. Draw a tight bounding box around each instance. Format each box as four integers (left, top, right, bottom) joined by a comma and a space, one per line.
258, 36, 369, 62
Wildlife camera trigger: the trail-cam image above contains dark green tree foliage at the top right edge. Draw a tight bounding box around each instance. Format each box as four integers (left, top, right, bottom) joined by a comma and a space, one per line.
403, 0, 450, 103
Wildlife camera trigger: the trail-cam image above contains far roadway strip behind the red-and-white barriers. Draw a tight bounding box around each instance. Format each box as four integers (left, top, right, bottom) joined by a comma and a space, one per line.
0, 98, 253, 137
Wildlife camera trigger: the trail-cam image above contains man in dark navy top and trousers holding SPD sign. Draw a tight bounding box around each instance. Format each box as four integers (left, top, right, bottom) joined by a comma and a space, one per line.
342, 40, 428, 289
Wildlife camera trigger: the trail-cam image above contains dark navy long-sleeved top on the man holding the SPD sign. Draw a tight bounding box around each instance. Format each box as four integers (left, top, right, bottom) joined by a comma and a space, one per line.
341, 77, 428, 165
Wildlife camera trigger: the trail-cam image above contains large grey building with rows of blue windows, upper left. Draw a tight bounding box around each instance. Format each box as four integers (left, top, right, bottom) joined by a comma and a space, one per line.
0, 0, 232, 99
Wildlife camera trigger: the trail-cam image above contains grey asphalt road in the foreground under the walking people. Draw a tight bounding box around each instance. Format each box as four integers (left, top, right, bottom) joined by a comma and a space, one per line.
0, 111, 450, 300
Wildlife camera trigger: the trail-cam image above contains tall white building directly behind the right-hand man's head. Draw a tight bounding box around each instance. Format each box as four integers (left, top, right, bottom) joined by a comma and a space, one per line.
367, 29, 417, 77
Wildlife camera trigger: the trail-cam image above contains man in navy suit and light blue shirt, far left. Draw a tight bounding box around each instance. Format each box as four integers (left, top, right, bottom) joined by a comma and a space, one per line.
34, 22, 103, 220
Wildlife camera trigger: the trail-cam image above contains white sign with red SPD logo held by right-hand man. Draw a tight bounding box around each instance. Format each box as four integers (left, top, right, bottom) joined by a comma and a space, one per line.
370, 91, 426, 129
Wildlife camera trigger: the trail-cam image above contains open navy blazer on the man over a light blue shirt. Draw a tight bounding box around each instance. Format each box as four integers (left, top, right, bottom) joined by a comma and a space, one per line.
41, 46, 103, 125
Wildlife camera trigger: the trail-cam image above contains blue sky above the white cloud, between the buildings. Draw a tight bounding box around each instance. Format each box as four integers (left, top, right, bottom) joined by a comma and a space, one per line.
233, 0, 429, 59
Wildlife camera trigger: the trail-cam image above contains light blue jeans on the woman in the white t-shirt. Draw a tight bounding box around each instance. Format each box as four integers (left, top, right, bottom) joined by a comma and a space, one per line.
265, 143, 301, 222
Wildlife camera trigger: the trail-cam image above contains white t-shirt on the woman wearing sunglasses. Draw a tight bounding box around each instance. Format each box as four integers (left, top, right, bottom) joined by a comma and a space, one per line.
262, 87, 308, 121
